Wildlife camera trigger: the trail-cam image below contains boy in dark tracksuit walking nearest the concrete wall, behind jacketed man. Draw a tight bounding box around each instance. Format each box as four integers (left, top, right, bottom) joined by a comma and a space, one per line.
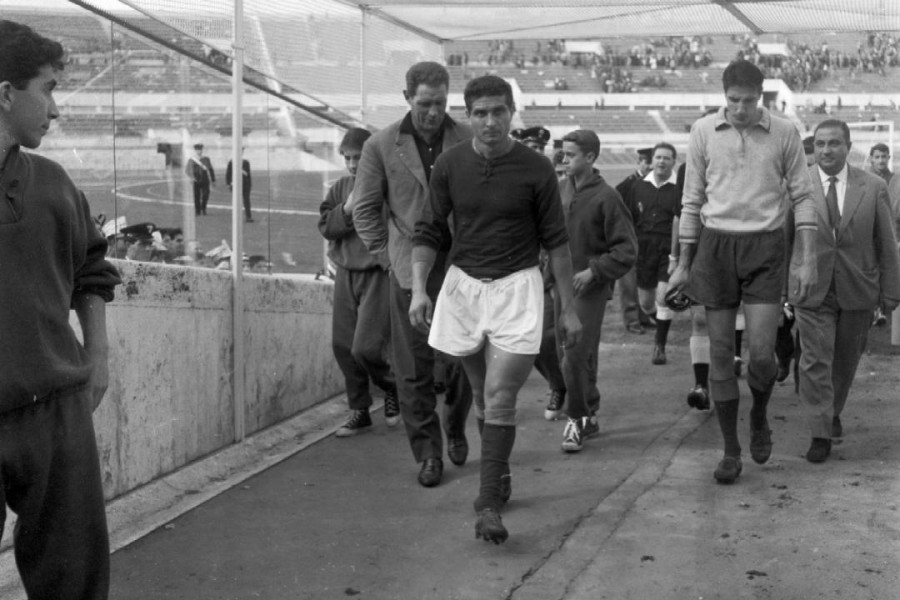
319, 127, 400, 437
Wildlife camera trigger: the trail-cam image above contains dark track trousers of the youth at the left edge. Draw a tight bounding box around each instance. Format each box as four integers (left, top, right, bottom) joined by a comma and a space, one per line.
0, 388, 109, 600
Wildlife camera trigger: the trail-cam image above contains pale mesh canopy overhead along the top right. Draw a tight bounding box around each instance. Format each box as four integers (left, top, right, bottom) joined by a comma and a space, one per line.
339, 0, 900, 41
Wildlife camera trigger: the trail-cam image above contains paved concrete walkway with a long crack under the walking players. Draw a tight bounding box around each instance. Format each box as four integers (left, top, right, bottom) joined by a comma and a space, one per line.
0, 325, 900, 600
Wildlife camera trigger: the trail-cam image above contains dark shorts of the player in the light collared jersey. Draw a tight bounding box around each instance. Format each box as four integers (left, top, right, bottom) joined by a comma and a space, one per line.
686, 228, 785, 309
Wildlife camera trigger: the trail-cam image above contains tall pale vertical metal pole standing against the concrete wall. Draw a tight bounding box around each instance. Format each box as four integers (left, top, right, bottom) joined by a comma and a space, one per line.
231, 0, 246, 442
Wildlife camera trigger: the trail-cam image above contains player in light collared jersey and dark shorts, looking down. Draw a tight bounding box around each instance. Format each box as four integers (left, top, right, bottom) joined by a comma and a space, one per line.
669, 60, 816, 483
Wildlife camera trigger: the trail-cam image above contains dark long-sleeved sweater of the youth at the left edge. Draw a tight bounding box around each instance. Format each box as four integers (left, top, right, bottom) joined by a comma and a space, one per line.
0, 147, 120, 413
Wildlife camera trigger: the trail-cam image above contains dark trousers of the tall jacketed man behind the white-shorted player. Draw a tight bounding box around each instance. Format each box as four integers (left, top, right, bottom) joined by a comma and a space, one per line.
391, 274, 472, 462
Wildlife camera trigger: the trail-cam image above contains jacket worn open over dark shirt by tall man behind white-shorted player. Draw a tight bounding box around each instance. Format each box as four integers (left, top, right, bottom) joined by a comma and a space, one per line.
353, 117, 472, 289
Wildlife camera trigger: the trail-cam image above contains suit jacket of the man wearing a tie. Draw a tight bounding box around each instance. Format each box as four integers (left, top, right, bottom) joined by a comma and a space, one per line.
788, 165, 900, 310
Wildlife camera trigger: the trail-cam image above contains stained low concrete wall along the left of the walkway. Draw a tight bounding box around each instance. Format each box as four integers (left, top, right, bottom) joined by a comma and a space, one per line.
91, 261, 343, 499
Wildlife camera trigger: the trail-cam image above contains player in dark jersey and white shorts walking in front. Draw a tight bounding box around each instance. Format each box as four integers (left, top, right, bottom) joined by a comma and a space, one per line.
409, 75, 581, 544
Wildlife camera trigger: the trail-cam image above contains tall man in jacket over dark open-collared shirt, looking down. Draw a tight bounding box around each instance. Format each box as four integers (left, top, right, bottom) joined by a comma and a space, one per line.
353, 62, 472, 487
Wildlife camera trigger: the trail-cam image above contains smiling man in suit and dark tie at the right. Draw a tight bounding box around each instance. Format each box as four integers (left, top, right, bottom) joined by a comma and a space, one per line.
788, 119, 900, 463
